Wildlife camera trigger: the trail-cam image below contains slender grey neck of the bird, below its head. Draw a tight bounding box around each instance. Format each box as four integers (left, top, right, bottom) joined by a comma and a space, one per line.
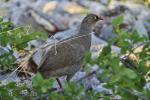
78, 23, 92, 35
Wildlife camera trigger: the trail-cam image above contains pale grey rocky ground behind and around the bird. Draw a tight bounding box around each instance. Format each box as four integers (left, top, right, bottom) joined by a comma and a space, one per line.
0, 0, 150, 97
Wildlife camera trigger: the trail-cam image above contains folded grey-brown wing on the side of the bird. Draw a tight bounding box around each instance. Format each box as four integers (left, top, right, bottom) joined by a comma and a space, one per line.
36, 42, 85, 71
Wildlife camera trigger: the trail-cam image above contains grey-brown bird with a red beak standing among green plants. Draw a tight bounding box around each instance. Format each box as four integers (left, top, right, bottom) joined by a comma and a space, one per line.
19, 14, 103, 87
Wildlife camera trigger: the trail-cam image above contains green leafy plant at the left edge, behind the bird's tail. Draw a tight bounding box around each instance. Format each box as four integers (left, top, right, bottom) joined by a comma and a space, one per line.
0, 18, 46, 70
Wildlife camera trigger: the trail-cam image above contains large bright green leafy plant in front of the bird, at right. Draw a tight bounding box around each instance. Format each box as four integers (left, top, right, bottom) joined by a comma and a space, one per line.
91, 16, 150, 100
